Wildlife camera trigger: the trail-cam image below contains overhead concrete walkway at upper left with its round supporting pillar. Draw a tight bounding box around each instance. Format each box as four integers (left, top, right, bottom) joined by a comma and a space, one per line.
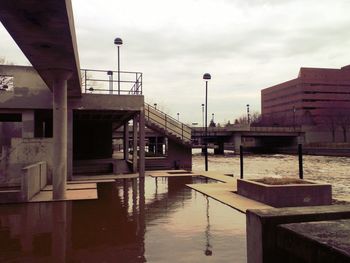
0, 0, 81, 199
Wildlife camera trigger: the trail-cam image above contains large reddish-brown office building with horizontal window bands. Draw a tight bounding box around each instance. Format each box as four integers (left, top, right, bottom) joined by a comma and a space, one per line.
261, 66, 350, 126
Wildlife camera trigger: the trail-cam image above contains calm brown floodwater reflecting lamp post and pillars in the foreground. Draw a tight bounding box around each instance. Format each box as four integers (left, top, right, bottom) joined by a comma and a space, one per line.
0, 177, 246, 263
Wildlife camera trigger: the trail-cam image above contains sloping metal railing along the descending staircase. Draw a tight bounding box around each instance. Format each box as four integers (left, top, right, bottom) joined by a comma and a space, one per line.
145, 103, 192, 143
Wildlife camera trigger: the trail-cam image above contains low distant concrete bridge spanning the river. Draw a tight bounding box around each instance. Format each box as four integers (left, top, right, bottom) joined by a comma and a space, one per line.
192, 125, 305, 154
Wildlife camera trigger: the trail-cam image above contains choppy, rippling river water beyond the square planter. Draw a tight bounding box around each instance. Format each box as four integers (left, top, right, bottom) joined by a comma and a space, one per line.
193, 150, 350, 198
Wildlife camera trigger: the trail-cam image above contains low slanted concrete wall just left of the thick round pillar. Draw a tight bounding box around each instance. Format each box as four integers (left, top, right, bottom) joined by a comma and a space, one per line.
21, 162, 47, 202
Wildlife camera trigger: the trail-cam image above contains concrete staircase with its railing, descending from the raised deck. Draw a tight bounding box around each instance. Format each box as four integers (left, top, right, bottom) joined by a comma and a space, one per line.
145, 103, 191, 147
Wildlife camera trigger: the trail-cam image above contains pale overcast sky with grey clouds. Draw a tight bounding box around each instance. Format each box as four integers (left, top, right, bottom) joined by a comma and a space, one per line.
0, 0, 350, 124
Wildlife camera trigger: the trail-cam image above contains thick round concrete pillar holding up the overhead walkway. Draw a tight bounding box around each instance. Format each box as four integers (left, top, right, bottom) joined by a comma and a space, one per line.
52, 70, 71, 200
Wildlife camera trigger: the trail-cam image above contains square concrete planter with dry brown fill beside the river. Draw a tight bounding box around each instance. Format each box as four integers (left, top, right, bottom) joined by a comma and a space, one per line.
237, 179, 332, 207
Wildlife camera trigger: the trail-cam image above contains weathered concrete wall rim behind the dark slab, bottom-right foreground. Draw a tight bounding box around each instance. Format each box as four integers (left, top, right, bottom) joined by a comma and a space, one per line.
246, 205, 350, 263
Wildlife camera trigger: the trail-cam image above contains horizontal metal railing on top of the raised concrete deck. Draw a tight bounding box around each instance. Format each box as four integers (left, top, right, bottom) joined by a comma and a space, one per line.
81, 69, 142, 95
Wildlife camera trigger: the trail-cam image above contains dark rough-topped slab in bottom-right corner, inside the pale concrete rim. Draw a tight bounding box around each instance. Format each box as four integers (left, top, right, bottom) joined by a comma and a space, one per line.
277, 219, 350, 263
